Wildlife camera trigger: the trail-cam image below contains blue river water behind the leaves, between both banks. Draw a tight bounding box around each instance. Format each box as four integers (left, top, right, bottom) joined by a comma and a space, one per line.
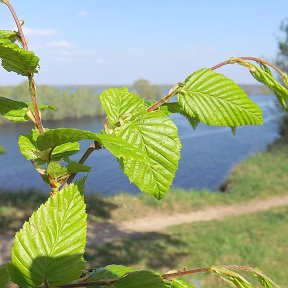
0, 96, 280, 195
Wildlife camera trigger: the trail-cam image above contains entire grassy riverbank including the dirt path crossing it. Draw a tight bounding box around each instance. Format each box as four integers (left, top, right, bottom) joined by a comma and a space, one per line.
0, 118, 288, 288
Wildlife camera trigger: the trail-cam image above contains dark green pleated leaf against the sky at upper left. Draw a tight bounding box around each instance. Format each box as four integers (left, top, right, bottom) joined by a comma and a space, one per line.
0, 39, 39, 76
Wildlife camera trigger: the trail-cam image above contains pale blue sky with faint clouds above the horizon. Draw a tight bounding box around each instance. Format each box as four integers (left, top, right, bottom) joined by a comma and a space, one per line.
0, 0, 288, 85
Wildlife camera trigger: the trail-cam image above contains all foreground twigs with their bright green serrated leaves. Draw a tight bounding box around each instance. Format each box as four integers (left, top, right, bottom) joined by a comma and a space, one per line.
0, 6, 288, 288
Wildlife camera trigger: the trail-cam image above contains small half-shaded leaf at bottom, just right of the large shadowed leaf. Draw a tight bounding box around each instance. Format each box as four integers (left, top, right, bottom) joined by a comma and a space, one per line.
88, 264, 135, 281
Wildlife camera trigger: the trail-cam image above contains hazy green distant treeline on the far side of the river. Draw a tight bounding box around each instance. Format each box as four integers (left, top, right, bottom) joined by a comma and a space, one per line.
0, 79, 271, 124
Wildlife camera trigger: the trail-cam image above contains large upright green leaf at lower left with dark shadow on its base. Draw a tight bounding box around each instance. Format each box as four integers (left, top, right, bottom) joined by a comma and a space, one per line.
10, 184, 87, 288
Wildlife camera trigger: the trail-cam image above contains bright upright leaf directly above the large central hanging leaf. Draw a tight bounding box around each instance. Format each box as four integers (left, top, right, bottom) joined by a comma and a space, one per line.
100, 88, 146, 126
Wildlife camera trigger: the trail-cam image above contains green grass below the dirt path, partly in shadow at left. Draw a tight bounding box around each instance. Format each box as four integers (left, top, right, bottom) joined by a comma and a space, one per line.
86, 207, 288, 287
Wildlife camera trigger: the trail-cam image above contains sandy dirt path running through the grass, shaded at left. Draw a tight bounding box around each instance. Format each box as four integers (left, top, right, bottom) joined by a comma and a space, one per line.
0, 195, 288, 265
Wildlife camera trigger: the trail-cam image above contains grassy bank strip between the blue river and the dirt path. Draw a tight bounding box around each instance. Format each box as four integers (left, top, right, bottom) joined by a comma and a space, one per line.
0, 120, 288, 234
